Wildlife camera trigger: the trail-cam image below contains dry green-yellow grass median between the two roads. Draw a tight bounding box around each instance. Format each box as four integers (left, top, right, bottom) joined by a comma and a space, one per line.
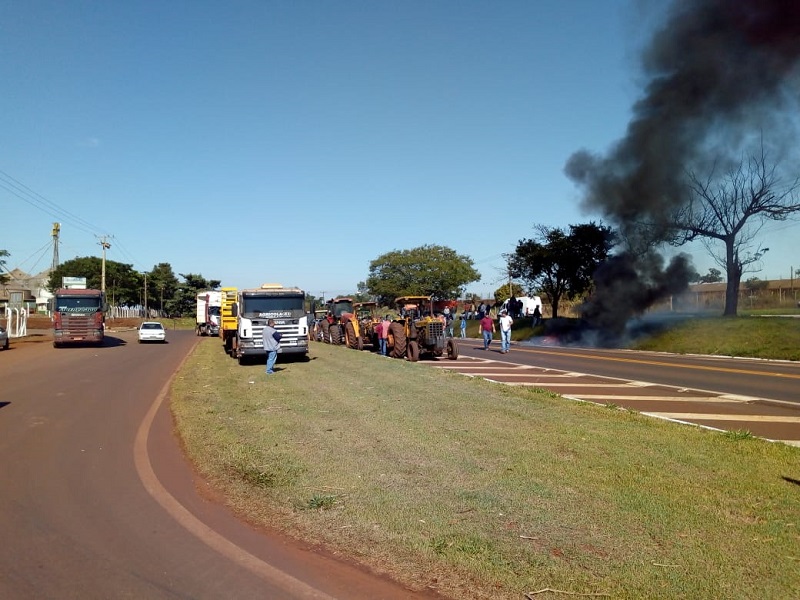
172, 339, 800, 599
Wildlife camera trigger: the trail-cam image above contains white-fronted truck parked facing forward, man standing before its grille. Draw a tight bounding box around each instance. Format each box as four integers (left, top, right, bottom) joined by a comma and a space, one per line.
223, 283, 308, 364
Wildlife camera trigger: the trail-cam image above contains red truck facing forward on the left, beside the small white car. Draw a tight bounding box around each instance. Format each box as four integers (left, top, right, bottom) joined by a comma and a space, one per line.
51, 288, 106, 348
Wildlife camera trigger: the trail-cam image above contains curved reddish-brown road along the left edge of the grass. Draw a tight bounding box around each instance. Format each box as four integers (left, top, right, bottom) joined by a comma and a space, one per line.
0, 331, 434, 600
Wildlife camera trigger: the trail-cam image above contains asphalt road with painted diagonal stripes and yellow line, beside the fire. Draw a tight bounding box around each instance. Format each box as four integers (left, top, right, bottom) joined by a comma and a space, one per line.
444, 339, 800, 446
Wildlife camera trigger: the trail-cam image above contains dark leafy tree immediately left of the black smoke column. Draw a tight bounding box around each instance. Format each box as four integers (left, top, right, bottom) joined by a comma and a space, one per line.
508, 222, 616, 317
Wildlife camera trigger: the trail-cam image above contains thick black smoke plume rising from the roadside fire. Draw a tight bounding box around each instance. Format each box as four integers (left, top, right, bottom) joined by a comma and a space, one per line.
565, 0, 800, 332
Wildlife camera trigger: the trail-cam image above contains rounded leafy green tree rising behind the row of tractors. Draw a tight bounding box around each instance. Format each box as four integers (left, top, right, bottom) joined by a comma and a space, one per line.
366, 245, 480, 305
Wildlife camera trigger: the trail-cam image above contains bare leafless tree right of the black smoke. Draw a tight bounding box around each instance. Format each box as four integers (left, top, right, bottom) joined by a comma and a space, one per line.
675, 145, 800, 316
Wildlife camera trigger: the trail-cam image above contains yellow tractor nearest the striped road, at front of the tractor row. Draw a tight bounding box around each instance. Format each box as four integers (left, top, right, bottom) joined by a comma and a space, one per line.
387, 296, 458, 362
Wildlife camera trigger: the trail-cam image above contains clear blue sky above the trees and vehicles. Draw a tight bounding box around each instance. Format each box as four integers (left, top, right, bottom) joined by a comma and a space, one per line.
0, 0, 800, 296
